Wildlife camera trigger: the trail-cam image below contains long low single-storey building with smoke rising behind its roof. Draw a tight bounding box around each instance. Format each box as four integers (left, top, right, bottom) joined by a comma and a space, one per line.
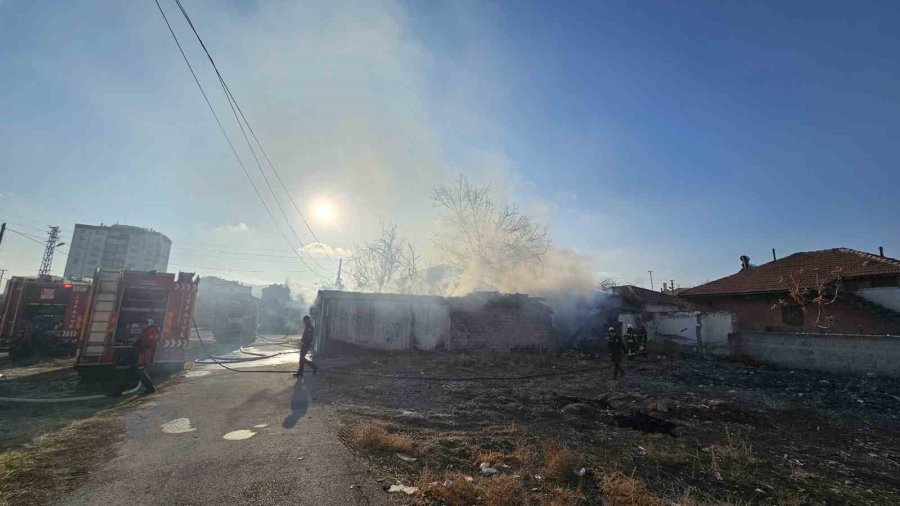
311, 290, 554, 351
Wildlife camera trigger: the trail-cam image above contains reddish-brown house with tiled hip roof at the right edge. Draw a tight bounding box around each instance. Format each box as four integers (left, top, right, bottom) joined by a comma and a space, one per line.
680, 248, 900, 335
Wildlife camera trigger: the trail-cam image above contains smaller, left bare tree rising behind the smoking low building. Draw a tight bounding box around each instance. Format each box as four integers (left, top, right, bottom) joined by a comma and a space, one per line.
350, 223, 418, 293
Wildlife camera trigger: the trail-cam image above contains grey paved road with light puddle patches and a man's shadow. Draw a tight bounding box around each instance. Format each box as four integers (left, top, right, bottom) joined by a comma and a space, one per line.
63, 371, 387, 505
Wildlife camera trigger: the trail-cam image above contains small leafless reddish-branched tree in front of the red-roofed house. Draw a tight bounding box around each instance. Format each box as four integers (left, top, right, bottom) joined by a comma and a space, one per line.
772, 267, 843, 329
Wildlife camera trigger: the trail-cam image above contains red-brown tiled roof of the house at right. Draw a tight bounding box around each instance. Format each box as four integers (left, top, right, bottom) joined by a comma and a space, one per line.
678, 248, 900, 298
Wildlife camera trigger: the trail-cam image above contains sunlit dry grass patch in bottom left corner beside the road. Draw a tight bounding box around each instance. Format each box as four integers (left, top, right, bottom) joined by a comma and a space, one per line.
0, 416, 118, 504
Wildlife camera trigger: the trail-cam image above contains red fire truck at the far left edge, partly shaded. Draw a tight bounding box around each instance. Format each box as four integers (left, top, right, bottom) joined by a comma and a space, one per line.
0, 276, 91, 360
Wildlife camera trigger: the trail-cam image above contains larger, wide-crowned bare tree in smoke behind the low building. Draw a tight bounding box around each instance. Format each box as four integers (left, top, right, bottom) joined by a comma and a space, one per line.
431, 175, 550, 286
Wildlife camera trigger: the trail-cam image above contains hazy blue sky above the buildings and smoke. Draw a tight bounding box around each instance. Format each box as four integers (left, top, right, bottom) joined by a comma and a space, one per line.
0, 0, 900, 289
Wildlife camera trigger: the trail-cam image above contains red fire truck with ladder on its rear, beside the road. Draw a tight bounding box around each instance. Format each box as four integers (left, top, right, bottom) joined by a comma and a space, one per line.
75, 269, 200, 372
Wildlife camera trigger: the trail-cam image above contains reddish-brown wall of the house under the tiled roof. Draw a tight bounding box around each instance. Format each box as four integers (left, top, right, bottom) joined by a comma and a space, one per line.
694, 294, 900, 335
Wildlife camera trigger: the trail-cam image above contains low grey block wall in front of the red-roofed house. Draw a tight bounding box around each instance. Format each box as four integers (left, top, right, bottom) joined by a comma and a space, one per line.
730, 332, 900, 377
